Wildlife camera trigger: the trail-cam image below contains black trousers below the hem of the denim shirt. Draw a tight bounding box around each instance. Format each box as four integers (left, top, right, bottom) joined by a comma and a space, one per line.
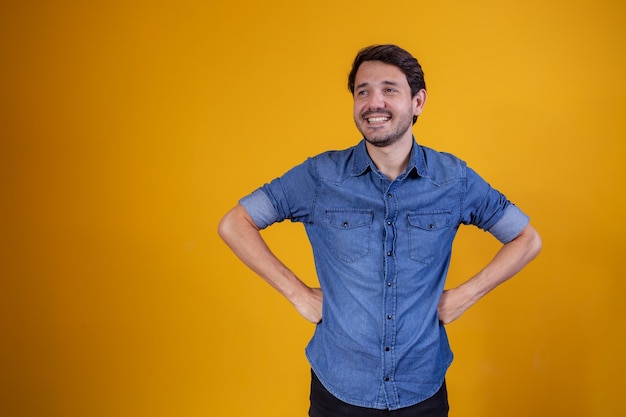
309, 371, 449, 417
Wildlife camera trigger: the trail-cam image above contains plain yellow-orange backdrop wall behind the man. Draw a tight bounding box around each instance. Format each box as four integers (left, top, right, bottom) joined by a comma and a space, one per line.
0, 0, 626, 417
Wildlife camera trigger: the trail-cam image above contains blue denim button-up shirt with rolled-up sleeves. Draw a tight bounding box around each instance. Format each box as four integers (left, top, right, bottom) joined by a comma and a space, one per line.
240, 140, 528, 410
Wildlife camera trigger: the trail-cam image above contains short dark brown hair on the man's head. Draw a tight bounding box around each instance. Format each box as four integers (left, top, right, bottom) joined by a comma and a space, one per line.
348, 45, 426, 97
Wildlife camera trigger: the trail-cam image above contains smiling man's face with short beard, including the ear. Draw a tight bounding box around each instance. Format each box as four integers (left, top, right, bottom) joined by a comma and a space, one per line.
354, 61, 426, 147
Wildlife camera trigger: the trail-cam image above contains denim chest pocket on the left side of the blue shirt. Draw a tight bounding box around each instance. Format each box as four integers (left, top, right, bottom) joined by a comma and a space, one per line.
324, 209, 374, 262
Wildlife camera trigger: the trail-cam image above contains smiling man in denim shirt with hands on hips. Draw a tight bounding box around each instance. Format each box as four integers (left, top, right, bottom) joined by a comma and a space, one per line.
219, 45, 541, 417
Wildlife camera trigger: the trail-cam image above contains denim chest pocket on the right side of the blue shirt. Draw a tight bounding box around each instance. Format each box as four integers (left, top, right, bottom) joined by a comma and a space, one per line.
408, 210, 452, 265
